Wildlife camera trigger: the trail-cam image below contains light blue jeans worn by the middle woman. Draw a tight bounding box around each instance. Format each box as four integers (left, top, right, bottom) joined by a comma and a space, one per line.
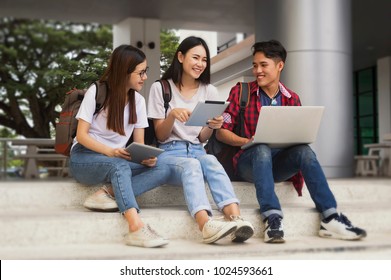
158, 141, 239, 217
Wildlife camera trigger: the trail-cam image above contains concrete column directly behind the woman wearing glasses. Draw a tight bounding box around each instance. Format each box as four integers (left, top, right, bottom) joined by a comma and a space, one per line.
113, 18, 160, 101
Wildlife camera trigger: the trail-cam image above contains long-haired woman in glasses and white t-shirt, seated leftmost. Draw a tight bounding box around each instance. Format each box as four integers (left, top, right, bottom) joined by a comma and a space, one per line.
70, 45, 169, 247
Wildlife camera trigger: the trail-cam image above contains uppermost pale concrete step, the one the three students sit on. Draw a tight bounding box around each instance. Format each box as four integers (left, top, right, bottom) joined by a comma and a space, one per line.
0, 178, 391, 210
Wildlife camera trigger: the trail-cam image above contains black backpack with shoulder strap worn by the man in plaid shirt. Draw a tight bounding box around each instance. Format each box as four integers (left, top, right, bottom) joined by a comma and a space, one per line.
205, 83, 250, 181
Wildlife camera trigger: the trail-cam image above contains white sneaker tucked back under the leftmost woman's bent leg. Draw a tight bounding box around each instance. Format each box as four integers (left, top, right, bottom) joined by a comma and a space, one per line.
83, 186, 118, 212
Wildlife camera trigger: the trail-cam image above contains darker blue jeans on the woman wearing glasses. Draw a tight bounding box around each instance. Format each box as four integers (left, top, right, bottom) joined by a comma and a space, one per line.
69, 144, 170, 213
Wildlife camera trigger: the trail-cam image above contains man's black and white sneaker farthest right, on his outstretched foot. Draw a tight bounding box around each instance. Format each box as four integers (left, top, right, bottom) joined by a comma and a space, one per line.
319, 213, 367, 240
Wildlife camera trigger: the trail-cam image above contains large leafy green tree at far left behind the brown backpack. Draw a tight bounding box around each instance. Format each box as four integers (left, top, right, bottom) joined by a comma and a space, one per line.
0, 18, 112, 138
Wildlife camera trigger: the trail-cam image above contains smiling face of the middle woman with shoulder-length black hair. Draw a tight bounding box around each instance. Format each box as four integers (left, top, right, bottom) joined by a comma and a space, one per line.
178, 45, 207, 79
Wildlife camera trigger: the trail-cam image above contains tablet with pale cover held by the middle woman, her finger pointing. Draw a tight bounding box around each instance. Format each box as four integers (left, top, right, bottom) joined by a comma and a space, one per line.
185, 100, 229, 126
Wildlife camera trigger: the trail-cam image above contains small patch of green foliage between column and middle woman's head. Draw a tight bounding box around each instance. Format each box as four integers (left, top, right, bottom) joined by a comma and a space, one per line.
160, 29, 179, 74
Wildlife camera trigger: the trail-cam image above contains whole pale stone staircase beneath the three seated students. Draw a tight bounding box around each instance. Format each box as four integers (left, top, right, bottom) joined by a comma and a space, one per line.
0, 178, 391, 260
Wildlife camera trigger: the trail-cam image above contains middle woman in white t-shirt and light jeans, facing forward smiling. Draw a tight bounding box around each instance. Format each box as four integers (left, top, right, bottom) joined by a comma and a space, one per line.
148, 37, 254, 243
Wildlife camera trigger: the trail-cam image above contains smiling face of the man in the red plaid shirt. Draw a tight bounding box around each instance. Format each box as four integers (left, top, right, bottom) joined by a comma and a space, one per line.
253, 52, 284, 88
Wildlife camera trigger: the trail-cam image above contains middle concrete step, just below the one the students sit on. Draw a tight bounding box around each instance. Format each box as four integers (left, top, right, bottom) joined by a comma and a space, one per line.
0, 203, 391, 247
